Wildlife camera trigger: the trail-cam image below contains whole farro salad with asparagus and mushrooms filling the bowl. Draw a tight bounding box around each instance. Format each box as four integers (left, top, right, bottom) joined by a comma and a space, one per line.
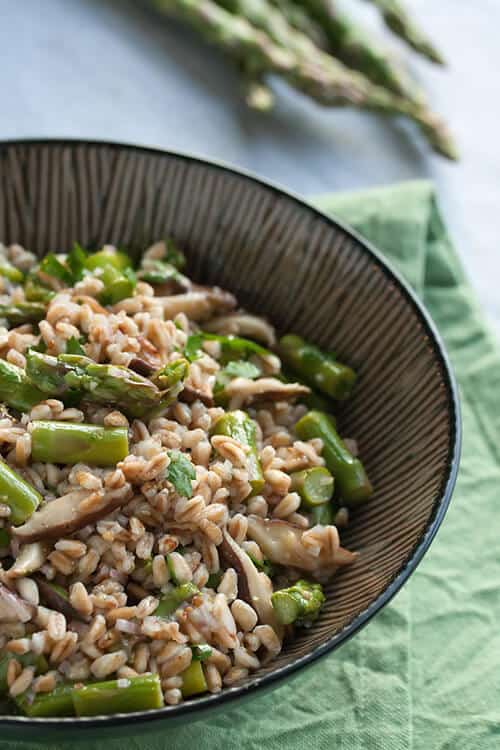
0, 241, 372, 717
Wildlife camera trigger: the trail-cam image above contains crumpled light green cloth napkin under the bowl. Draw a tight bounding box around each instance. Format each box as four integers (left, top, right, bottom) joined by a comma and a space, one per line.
9, 182, 500, 750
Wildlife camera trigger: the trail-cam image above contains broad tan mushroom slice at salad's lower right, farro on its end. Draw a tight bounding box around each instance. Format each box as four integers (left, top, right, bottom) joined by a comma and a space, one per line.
247, 516, 357, 573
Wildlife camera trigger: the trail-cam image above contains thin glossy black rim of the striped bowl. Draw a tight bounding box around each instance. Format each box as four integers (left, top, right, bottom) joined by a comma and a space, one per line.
0, 136, 462, 732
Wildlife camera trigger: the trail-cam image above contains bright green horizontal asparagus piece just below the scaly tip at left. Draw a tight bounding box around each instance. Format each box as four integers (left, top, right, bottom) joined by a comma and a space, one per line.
31, 421, 128, 466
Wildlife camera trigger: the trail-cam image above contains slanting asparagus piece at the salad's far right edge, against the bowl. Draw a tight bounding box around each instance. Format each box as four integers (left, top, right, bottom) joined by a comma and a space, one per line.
295, 411, 373, 506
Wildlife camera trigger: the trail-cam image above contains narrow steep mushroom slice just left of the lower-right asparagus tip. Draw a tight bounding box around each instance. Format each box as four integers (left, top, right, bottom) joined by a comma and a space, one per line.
219, 531, 283, 638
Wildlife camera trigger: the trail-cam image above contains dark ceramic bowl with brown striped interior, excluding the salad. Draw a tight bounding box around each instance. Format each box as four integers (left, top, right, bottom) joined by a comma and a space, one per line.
0, 141, 460, 740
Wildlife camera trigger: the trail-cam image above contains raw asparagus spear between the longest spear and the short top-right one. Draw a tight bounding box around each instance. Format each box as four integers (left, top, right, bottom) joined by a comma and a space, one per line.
290, 0, 422, 102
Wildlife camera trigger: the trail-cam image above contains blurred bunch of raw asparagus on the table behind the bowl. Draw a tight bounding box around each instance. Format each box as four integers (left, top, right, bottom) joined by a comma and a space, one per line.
146, 0, 457, 159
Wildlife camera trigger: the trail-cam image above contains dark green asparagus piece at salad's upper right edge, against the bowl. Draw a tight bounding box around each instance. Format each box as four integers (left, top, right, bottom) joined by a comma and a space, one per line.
280, 334, 356, 401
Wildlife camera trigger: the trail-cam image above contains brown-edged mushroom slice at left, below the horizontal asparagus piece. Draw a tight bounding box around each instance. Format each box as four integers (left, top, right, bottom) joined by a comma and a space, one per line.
12, 488, 131, 542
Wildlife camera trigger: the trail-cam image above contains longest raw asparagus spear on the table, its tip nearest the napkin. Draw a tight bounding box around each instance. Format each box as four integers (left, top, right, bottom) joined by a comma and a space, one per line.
178, 0, 457, 159
